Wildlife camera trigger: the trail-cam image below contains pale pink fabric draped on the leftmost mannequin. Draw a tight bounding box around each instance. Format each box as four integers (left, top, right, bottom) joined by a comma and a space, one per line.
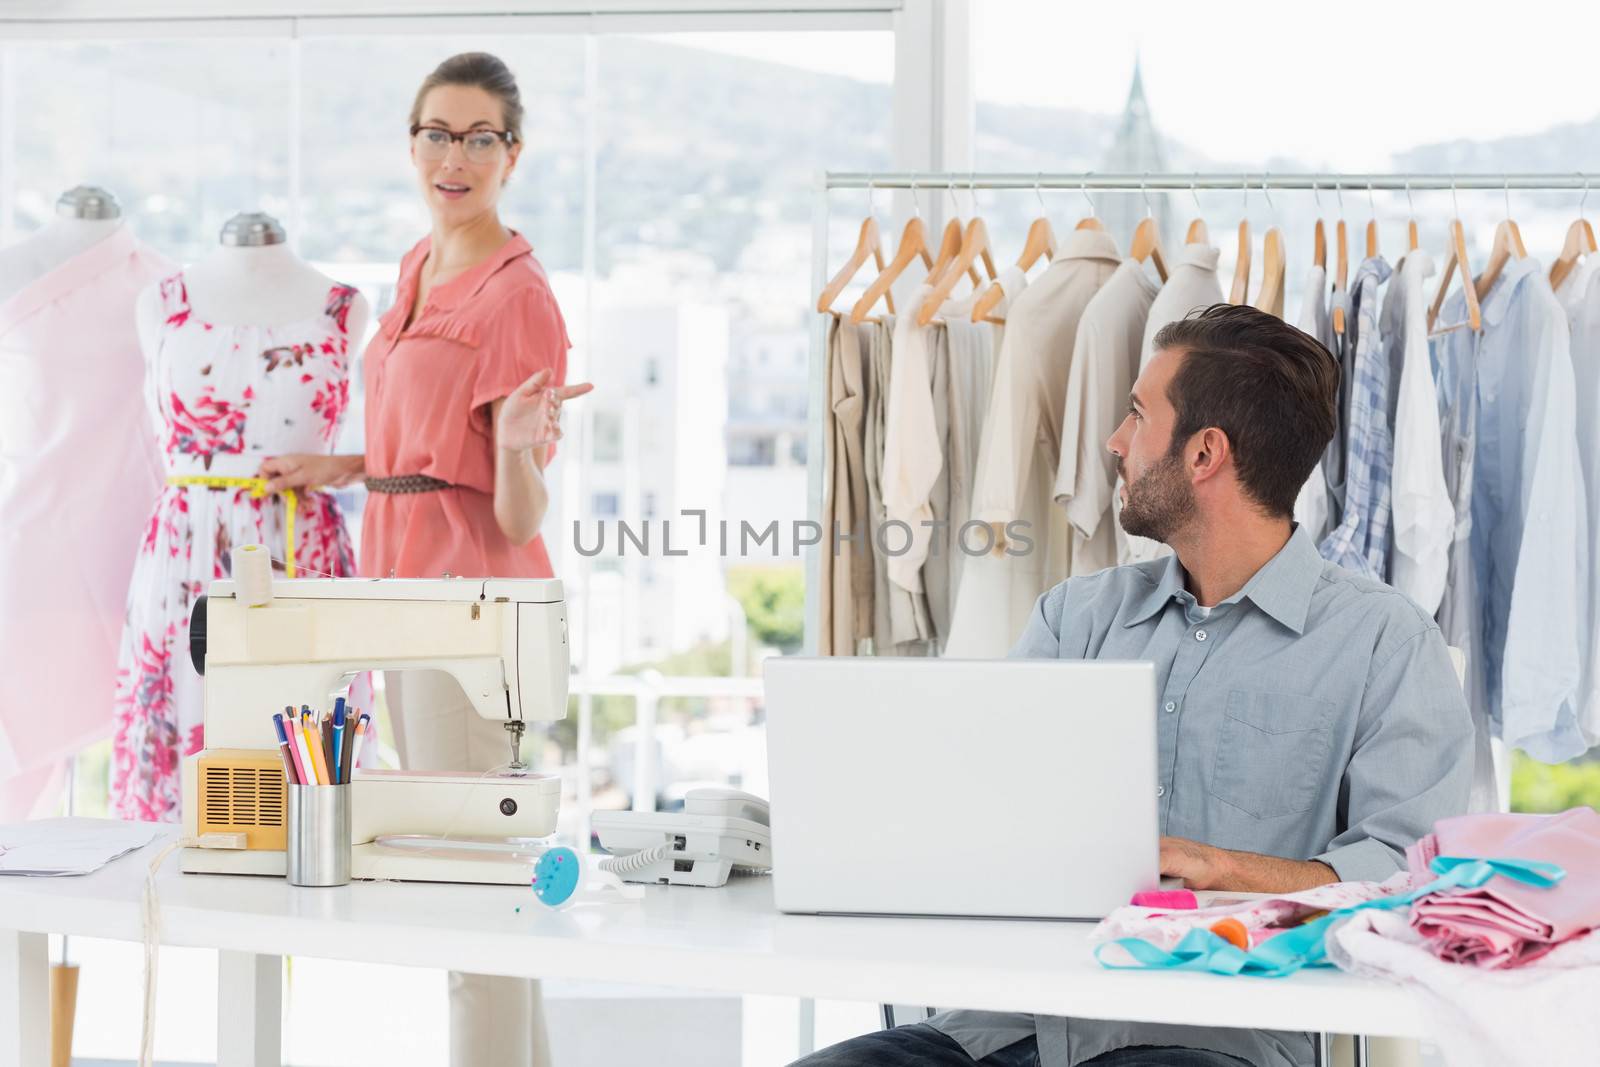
0, 227, 170, 790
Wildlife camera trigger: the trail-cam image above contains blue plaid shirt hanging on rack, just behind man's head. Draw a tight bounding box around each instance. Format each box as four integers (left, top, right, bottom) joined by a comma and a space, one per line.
1322, 256, 1395, 581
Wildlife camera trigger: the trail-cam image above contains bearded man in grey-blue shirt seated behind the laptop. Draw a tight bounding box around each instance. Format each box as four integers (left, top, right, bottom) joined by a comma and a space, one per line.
803, 304, 1472, 1067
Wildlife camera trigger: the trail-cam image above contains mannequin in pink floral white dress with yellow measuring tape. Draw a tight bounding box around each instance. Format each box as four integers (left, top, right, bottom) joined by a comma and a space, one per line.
112, 213, 371, 821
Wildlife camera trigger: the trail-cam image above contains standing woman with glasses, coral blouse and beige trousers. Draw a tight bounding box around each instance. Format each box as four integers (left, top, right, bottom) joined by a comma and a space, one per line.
262, 53, 590, 1067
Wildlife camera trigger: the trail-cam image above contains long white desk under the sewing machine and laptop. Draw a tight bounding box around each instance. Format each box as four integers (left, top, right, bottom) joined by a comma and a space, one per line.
0, 838, 1422, 1067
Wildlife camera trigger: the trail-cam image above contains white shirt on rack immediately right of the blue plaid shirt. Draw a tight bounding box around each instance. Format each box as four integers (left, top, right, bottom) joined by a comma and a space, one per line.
1381, 251, 1456, 614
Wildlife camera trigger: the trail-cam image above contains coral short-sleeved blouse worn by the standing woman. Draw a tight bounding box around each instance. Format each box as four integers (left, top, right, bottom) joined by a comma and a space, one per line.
358, 234, 571, 577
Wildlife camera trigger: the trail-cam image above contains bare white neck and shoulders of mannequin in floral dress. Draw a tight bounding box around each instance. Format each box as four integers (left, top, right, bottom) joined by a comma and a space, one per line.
138, 213, 371, 352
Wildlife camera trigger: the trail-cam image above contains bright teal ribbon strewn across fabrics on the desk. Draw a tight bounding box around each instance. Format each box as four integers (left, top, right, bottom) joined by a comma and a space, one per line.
1094, 856, 1566, 977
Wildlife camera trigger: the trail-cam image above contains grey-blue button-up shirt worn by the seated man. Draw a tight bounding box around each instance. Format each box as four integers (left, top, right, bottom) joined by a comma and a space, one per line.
933, 530, 1472, 1067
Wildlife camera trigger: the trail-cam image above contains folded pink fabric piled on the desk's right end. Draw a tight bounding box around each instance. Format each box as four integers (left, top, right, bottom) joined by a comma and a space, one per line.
1406, 808, 1600, 968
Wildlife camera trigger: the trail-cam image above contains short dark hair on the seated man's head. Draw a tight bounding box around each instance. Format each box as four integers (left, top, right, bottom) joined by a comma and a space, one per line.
1152, 304, 1339, 517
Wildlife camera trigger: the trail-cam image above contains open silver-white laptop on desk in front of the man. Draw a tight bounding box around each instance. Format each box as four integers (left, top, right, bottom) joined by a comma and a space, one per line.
765, 657, 1160, 920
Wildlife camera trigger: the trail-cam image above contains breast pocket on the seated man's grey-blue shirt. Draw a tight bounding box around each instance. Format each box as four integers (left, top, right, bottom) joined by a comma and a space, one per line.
1211, 689, 1334, 819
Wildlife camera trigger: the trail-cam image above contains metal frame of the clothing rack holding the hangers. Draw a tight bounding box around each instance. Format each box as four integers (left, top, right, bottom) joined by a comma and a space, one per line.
803, 171, 1600, 656
